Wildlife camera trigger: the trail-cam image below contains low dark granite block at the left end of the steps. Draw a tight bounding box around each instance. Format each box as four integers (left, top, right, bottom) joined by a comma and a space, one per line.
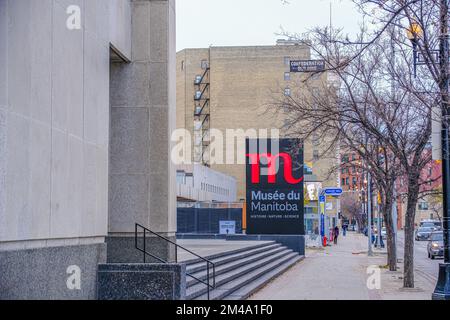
98, 264, 186, 300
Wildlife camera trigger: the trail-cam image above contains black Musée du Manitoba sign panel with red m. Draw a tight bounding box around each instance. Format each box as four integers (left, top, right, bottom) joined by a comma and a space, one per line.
246, 139, 305, 235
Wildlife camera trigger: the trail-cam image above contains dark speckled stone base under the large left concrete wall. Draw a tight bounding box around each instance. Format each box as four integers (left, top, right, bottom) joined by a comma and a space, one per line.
0, 243, 106, 300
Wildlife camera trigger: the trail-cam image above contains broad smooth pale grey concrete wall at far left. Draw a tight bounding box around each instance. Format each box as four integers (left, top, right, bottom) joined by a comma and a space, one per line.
0, 0, 109, 248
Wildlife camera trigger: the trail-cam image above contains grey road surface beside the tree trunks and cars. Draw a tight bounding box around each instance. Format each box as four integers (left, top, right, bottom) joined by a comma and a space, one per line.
398, 231, 444, 285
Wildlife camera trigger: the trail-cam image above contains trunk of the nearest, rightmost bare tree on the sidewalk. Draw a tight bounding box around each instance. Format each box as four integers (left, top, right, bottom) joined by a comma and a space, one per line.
403, 181, 419, 288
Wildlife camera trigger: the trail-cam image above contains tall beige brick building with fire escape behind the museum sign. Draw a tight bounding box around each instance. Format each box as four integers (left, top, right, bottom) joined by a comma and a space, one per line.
177, 41, 337, 200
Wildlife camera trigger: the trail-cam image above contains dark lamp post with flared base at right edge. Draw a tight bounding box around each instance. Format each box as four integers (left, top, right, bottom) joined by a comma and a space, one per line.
433, 0, 450, 300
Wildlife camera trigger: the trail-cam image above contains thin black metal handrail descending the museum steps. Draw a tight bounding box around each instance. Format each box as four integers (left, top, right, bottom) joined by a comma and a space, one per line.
134, 223, 216, 300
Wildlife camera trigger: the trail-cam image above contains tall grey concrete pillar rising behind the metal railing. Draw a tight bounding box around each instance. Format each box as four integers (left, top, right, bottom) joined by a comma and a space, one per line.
108, 0, 176, 262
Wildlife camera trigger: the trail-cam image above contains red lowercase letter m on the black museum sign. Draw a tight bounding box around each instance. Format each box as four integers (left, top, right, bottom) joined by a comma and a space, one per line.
247, 153, 303, 184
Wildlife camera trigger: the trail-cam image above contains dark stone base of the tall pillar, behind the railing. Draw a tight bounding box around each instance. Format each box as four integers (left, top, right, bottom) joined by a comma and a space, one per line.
106, 234, 176, 263
